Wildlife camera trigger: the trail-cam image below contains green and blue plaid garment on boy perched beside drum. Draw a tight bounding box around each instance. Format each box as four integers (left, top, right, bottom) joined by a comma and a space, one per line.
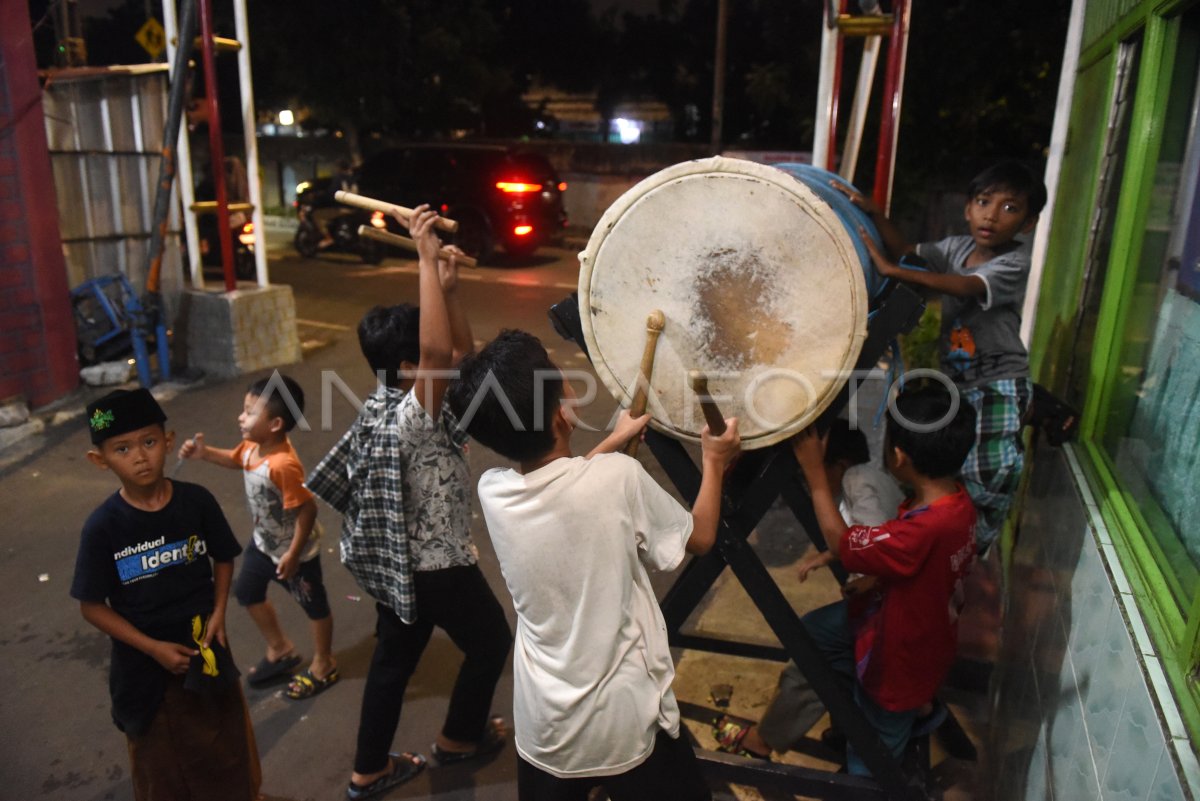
961, 378, 1032, 554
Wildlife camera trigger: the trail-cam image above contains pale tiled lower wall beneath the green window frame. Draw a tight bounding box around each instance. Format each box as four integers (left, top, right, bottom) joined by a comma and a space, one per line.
992, 450, 1195, 801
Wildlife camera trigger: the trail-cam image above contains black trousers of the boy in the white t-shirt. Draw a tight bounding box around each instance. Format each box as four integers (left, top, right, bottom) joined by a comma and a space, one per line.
517, 728, 713, 801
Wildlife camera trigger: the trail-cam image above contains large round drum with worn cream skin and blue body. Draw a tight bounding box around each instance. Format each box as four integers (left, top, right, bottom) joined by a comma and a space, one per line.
578, 157, 881, 448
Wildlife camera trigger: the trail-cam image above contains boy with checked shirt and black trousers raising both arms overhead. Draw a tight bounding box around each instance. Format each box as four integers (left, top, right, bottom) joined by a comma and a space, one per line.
307, 205, 512, 801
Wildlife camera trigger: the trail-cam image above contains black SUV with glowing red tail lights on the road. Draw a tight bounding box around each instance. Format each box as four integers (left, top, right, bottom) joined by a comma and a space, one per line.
359, 144, 566, 260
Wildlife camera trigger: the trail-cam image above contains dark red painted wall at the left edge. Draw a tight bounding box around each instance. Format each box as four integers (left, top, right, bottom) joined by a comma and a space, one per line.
0, 2, 79, 406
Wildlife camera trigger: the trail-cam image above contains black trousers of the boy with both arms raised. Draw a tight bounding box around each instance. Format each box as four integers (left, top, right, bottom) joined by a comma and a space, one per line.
354, 565, 512, 773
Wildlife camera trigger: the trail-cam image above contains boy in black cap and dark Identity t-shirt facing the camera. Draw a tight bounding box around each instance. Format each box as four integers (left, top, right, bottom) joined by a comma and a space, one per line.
71, 390, 262, 801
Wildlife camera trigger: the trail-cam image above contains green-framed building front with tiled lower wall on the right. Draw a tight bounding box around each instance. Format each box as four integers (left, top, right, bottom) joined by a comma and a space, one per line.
989, 0, 1200, 801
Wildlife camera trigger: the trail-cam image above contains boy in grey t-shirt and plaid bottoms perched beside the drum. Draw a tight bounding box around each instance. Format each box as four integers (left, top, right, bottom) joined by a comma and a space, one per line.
834, 161, 1046, 554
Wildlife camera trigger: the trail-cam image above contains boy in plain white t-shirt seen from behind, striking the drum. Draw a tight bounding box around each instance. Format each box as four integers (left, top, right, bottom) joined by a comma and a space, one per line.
449, 331, 740, 801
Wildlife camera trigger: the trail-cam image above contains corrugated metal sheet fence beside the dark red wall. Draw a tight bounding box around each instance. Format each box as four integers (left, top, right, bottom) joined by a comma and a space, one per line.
43, 65, 184, 306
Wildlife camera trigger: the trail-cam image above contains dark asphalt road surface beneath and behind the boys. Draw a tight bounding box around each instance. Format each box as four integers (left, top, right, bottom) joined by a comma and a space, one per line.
0, 237, 700, 801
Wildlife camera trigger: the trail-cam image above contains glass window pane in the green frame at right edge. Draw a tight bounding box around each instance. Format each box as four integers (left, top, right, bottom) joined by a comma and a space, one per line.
1098, 10, 1200, 610
